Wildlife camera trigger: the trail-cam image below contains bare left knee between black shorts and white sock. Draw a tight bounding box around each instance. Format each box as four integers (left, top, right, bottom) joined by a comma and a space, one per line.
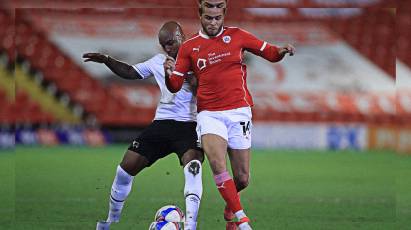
120, 150, 149, 176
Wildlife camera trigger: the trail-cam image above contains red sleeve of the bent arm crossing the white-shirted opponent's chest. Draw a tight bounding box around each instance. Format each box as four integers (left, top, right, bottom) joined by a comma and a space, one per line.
166, 43, 191, 93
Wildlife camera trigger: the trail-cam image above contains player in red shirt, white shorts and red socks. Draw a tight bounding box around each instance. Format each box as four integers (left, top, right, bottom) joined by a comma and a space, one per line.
164, 0, 295, 230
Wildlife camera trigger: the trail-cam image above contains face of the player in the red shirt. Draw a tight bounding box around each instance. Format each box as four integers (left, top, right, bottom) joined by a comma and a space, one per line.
201, 7, 224, 37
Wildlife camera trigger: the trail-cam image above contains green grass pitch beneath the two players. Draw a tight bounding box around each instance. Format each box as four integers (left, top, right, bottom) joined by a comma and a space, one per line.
0, 145, 411, 230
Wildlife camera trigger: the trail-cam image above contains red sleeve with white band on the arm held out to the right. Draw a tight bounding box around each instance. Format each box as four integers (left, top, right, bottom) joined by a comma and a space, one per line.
240, 29, 283, 62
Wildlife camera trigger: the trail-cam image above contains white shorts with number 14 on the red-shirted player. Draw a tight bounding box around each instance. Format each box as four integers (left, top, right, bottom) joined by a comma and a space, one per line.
197, 107, 252, 149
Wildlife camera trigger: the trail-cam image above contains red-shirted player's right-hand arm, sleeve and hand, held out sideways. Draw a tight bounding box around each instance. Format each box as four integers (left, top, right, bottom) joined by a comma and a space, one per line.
241, 30, 295, 62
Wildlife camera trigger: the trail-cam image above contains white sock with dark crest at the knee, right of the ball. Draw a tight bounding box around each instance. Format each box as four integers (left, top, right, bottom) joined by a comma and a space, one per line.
184, 160, 203, 230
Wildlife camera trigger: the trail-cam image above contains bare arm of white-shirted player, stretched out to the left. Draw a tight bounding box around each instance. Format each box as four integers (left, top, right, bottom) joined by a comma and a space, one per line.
83, 53, 143, 80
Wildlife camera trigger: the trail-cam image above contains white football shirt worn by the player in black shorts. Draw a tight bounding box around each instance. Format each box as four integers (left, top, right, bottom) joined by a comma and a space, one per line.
133, 54, 197, 121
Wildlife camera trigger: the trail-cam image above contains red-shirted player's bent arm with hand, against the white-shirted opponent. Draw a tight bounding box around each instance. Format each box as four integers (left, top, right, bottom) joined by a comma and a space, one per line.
164, 46, 191, 93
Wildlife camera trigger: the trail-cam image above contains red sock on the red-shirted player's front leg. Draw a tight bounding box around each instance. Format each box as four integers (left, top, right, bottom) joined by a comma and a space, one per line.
214, 172, 243, 213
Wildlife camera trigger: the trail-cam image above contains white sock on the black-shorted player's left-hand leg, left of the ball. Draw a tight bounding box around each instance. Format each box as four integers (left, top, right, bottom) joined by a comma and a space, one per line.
107, 165, 134, 222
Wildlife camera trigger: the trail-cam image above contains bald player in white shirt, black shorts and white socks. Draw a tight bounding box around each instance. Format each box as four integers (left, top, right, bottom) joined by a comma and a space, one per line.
83, 21, 204, 230
